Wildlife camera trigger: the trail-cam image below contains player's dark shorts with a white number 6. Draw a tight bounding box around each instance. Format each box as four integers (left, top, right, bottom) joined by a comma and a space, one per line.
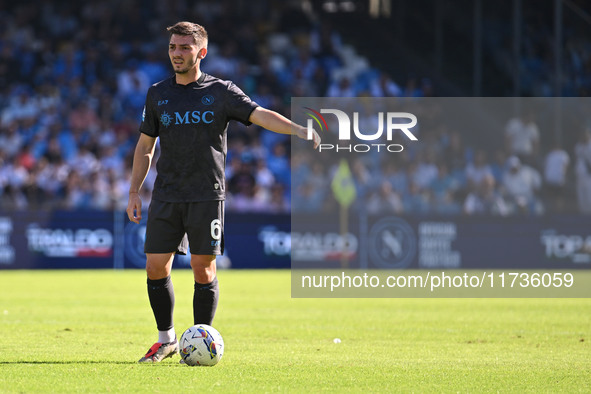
144, 200, 224, 255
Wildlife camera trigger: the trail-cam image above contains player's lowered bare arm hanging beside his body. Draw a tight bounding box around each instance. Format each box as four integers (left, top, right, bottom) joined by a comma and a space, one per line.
126, 133, 156, 223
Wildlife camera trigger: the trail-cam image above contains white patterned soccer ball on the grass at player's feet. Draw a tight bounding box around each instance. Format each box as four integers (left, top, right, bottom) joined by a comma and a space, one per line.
179, 324, 224, 367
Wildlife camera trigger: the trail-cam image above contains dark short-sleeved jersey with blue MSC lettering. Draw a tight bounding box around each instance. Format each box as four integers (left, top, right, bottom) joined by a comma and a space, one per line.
140, 73, 258, 202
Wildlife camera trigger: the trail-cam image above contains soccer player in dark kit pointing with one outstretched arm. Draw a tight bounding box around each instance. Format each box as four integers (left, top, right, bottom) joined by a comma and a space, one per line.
127, 22, 320, 363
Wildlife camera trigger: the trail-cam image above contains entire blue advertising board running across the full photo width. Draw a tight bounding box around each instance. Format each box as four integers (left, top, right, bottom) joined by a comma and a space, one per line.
0, 211, 591, 269
